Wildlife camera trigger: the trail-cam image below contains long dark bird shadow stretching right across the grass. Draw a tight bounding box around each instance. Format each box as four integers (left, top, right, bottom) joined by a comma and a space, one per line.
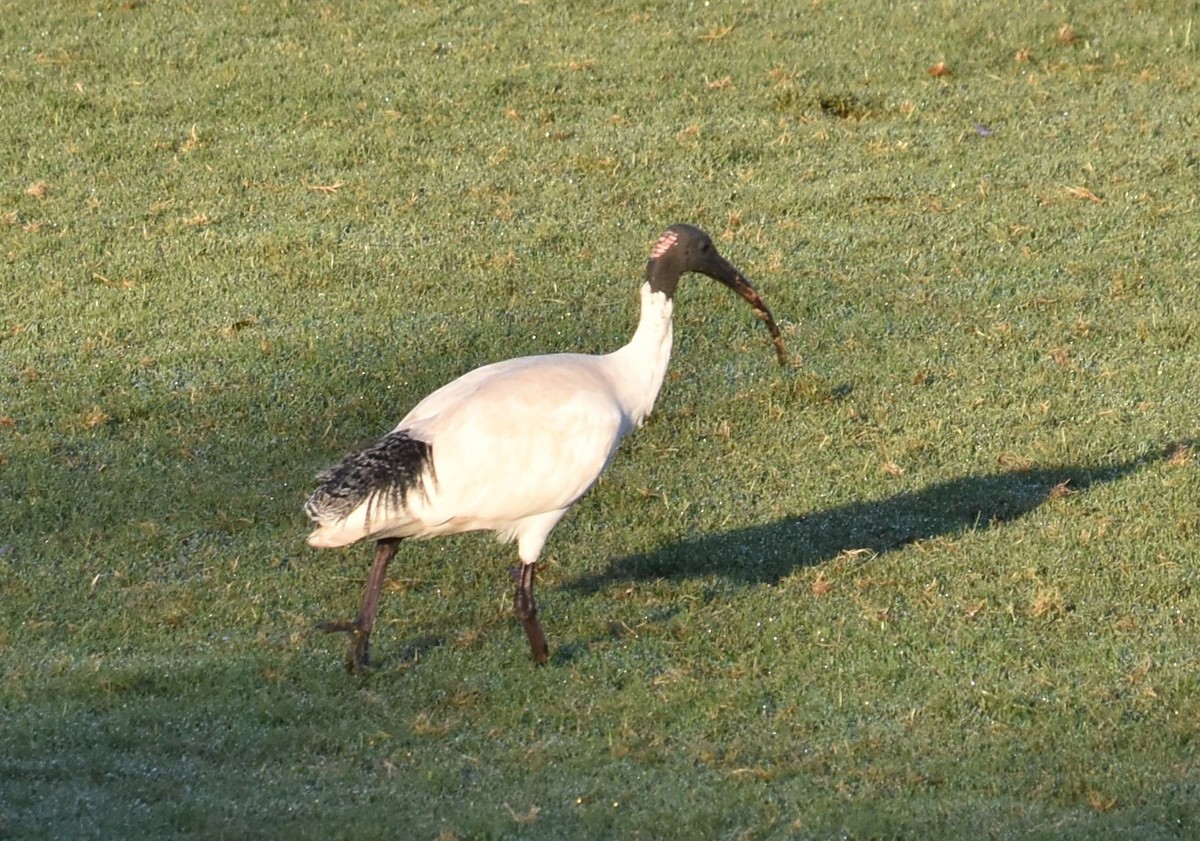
566, 443, 1189, 593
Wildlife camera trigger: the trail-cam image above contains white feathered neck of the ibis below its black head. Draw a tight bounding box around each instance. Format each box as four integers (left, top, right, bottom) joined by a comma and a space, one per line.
604, 283, 673, 426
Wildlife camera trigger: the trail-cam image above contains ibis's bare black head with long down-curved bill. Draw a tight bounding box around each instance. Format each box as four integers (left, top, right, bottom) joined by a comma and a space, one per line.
646, 223, 787, 365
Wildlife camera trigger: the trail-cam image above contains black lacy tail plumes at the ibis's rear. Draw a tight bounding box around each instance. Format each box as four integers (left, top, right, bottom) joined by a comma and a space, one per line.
305, 429, 433, 523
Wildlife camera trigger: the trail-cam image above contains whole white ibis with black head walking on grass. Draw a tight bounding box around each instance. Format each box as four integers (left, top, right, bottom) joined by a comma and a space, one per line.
305, 224, 787, 672
